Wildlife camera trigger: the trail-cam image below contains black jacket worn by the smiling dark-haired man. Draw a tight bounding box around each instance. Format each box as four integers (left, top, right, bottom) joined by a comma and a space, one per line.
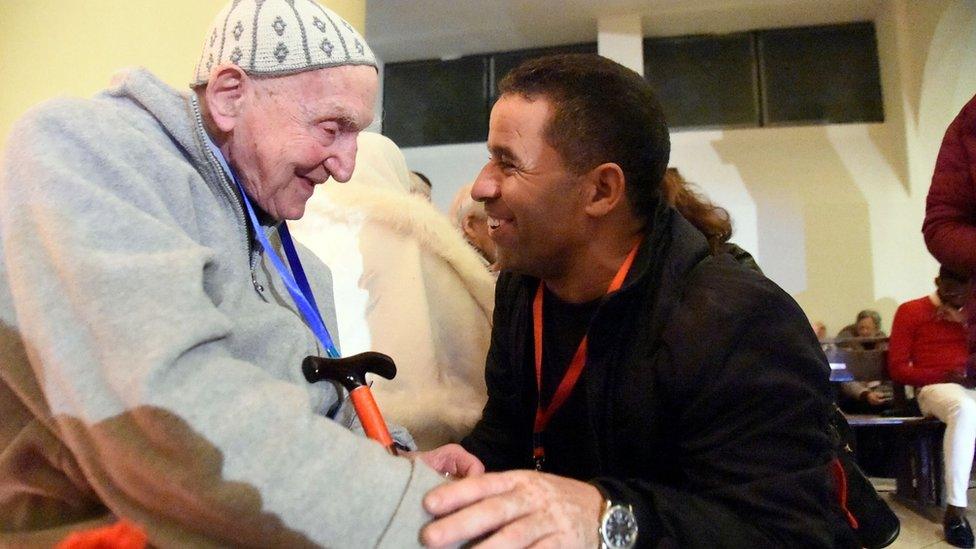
462, 208, 856, 547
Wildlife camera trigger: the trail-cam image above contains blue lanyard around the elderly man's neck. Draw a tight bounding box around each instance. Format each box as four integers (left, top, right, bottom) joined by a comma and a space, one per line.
207, 135, 340, 358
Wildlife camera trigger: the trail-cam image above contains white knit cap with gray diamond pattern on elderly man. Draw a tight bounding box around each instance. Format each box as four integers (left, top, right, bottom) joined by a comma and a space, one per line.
190, 0, 376, 87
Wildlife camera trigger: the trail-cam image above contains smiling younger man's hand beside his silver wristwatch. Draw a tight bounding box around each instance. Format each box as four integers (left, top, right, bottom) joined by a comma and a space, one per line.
420, 471, 603, 548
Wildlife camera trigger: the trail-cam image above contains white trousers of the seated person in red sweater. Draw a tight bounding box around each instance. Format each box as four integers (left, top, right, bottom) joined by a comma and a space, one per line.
918, 383, 976, 507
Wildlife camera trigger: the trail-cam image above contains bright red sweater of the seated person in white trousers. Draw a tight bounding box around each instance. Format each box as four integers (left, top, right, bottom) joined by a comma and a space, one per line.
888, 296, 969, 387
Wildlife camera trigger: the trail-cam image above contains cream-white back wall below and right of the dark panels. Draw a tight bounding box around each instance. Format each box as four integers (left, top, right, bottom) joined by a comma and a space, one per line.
394, 0, 976, 332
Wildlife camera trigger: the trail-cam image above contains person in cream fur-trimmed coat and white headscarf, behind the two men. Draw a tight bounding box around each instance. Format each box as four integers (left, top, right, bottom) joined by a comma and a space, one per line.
291, 132, 495, 450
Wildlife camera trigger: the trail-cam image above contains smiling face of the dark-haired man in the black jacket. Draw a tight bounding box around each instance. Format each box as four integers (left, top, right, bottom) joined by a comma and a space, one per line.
471, 95, 586, 280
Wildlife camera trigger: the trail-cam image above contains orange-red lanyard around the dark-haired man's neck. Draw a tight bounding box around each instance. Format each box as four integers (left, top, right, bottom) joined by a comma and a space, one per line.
532, 241, 640, 471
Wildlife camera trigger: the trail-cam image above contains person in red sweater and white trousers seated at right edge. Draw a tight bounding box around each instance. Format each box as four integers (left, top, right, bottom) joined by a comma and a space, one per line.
888, 267, 976, 547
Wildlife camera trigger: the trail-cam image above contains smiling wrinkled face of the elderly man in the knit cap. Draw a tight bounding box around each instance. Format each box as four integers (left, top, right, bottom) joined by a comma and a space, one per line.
228, 66, 377, 220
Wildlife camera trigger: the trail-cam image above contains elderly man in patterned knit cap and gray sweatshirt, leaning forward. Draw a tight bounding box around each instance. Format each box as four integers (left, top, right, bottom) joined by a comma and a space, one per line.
0, 0, 480, 547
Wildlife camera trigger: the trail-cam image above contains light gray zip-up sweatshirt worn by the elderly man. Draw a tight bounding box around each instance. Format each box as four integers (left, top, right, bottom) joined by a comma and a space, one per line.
0, 70, 441, 547
